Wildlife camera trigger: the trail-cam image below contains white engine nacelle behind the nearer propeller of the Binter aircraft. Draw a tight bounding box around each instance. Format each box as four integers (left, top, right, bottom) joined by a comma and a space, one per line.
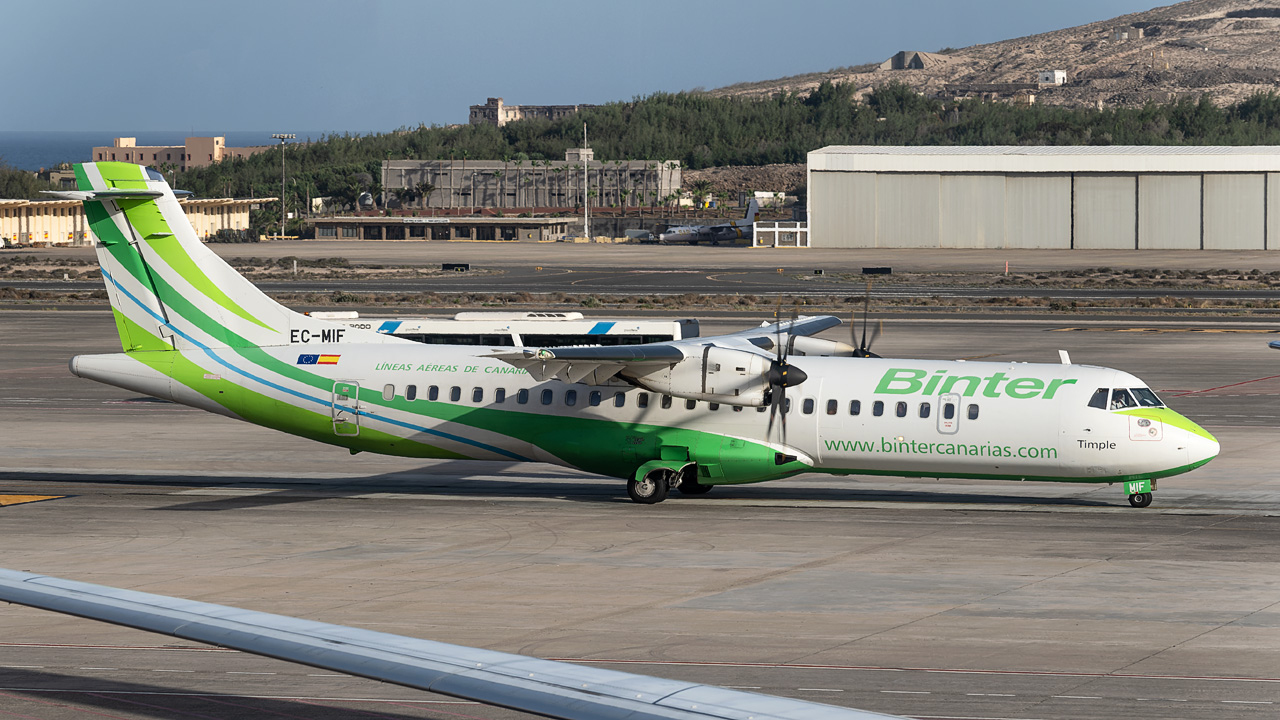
620, 345, 772, 407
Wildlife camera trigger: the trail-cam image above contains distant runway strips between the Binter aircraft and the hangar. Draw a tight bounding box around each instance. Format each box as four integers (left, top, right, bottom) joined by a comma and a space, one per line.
12, 241, 1280, 300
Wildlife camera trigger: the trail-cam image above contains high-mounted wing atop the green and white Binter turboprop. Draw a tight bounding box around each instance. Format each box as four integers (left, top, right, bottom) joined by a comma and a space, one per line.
490, 315, 841, 384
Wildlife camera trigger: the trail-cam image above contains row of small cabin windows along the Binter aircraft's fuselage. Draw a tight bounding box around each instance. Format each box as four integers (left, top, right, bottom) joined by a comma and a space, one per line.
383, 384, 978, 420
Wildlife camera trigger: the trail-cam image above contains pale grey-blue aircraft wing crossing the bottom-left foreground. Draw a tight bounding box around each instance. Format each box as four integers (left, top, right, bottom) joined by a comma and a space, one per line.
0, 569, 891, 720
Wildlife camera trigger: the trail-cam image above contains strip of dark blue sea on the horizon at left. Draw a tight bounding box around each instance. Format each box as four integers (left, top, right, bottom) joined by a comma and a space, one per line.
0, 131, 340, 170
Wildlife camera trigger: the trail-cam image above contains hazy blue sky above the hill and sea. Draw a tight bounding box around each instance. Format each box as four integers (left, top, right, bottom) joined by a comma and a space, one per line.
0, 0, 1156, 133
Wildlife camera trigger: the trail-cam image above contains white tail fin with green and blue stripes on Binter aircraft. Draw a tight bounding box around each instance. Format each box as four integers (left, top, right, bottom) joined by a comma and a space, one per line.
55, 163, 387, 352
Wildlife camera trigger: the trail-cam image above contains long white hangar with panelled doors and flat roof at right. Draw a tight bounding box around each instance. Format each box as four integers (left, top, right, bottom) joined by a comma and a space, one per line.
809, 146, 1280, 250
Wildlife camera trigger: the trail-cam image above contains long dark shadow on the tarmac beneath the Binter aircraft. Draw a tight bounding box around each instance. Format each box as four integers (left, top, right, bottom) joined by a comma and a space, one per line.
0, 461, 1123, 512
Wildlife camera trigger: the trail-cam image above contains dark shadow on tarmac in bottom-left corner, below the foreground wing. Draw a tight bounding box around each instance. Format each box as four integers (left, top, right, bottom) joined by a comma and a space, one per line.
0, 669, 435, 720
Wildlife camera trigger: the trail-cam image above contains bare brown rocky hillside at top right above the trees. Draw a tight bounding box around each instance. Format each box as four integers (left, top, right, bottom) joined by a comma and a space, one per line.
710, 0, 1280, 106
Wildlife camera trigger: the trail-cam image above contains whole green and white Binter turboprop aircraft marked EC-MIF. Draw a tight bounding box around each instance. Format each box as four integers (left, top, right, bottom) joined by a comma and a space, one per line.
58, 163, 1219, 507
